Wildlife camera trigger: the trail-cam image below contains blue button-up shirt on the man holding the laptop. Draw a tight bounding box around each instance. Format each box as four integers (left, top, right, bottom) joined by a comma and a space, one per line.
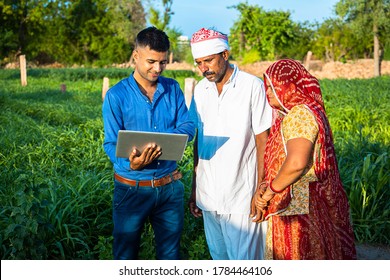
103, 74, 195, 180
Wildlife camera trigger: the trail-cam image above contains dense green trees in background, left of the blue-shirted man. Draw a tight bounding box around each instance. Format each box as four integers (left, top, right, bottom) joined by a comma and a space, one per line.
0, 0, 146, 65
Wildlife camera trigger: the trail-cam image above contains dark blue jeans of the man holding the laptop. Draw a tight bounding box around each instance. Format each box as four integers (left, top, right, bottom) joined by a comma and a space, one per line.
113, 180, 184, 260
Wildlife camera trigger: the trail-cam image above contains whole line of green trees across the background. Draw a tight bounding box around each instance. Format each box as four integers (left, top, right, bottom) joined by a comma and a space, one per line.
0, 0, 390, 75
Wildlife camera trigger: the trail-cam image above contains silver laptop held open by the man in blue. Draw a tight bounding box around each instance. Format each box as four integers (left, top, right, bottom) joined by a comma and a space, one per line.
116, 130, 188, 161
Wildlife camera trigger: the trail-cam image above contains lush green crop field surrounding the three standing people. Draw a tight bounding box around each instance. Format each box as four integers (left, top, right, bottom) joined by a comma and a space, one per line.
0, 69, 390, 260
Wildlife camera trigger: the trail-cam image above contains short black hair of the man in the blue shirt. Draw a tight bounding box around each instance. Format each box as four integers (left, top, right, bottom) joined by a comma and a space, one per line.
135, 26, 170, 52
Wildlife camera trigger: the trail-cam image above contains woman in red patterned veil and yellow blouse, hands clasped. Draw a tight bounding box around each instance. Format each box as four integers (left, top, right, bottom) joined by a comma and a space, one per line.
254, 59, 356, 260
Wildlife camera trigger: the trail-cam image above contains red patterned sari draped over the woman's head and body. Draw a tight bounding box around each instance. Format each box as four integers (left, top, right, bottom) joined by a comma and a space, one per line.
264, 59, 356, 259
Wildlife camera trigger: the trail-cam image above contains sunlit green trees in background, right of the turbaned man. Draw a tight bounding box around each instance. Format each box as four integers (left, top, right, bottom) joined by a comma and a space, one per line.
230, 0, 390, 62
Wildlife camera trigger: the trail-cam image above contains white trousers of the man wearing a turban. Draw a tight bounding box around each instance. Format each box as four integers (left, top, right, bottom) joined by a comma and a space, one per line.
203, 211, 267, 260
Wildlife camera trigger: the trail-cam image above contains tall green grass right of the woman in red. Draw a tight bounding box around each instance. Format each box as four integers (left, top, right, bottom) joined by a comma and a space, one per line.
321, 76, 390, 244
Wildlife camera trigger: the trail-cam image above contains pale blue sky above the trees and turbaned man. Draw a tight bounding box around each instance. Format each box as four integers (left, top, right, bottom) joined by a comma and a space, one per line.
170, 0, 339, 37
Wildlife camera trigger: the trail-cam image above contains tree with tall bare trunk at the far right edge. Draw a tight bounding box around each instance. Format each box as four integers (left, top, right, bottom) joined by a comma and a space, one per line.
336, 0, 390, 76
